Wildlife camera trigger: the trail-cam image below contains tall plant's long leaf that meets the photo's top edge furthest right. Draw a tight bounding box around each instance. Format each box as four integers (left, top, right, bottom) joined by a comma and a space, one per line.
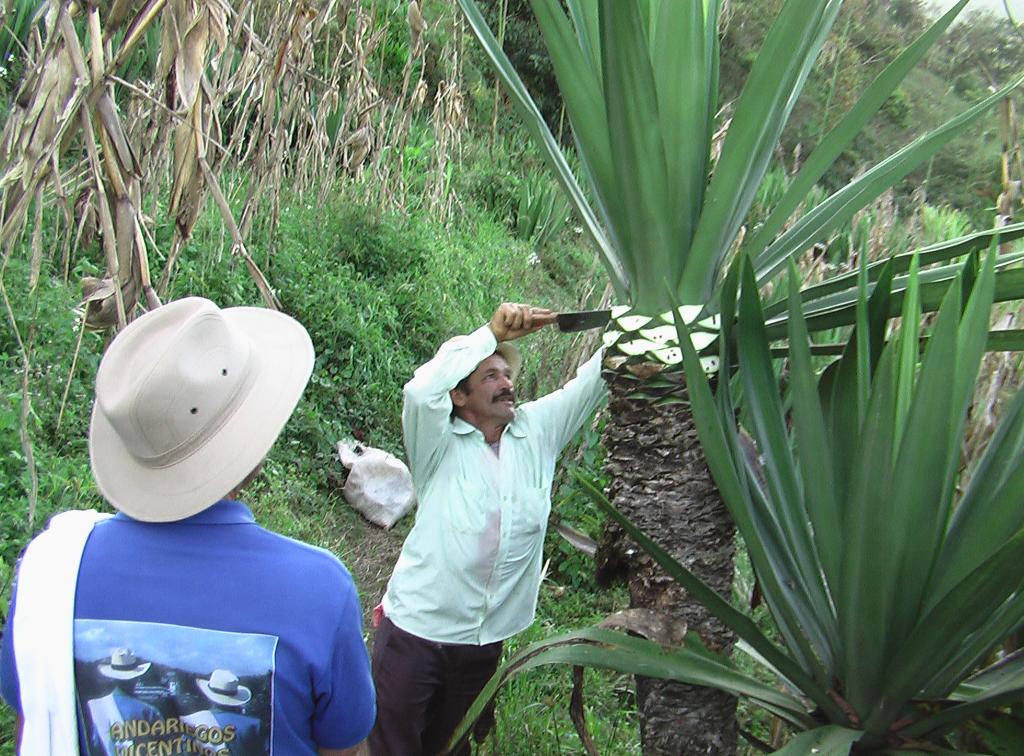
746, 0, 968, 258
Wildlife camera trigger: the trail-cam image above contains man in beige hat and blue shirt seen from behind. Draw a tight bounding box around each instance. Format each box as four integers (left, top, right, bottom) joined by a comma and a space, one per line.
0, 298, 376, 756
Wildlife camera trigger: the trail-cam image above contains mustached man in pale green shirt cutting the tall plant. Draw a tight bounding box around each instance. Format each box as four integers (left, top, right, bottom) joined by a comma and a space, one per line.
370, 303, 605, 756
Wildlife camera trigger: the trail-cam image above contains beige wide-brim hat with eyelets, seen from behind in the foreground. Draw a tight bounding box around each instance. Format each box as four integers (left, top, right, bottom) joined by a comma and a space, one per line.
89, 297, 313, 522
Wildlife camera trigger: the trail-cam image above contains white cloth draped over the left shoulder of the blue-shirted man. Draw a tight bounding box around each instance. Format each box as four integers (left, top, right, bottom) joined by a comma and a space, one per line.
11, 509, 111, 756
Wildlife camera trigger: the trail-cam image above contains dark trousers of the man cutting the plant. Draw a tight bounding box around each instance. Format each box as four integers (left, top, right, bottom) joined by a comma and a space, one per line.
370, 617, 502, 756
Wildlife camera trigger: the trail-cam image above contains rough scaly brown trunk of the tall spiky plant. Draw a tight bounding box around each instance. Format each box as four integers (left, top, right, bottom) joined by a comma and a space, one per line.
604, 374, 736, 756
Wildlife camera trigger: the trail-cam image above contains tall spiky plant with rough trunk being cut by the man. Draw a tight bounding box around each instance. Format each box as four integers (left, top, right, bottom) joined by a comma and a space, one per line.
459, 0, 1024, 754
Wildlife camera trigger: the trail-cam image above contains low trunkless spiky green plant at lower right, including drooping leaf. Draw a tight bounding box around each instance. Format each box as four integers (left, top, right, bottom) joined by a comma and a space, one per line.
456, 244, 1024, 754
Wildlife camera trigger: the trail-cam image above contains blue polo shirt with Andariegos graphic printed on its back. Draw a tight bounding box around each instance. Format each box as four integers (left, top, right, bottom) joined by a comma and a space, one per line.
0, 500, 376, 754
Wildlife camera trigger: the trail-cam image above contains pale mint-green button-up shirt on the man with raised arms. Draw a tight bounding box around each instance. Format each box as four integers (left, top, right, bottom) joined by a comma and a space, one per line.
383, 326, 605, 645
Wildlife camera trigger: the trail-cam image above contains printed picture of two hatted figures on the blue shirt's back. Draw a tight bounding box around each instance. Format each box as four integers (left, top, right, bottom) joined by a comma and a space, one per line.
75, 620, 278, 756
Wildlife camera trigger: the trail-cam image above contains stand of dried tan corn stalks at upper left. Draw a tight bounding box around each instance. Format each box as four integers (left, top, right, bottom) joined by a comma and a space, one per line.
0, 0, 450, 328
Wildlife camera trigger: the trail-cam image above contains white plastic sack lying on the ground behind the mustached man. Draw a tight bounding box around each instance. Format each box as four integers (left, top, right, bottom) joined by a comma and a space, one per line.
338, 440, 416, 530
